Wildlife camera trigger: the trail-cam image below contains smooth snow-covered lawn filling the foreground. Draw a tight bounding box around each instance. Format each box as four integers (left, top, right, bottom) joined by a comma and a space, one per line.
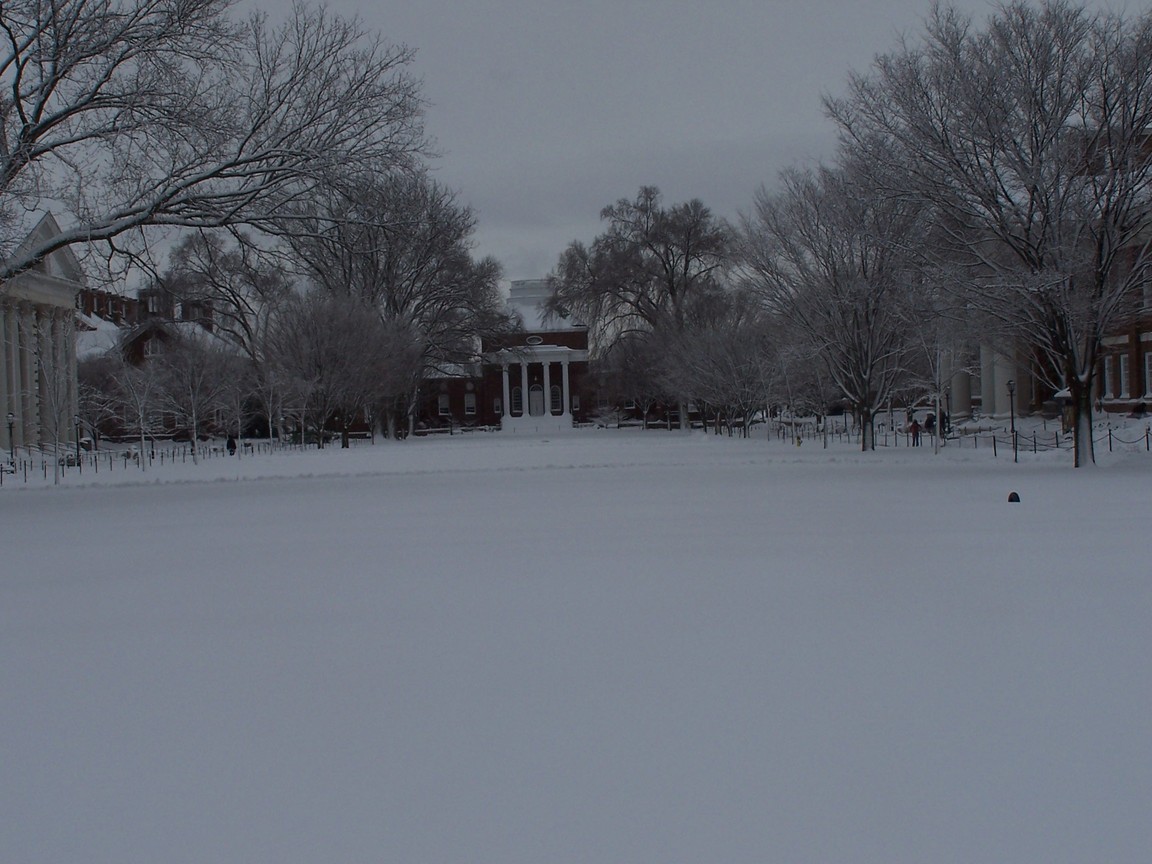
0, 430, 1152, 864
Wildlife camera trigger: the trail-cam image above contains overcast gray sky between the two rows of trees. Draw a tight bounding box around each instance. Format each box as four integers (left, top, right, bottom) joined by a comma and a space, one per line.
328, 0, 1104, 279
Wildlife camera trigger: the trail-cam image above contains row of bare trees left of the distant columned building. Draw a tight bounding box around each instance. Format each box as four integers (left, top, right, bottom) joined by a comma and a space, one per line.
0, 0, 511, 456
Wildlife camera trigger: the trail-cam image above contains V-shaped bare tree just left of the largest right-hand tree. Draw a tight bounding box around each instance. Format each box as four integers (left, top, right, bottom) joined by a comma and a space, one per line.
743, 168, 922, 450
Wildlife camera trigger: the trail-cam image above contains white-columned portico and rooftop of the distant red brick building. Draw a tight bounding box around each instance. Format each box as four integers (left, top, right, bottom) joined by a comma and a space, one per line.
485, 279, 588, 433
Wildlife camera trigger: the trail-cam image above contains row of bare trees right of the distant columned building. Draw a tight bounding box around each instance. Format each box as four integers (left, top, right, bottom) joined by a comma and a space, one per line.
552, 0, 1152, 465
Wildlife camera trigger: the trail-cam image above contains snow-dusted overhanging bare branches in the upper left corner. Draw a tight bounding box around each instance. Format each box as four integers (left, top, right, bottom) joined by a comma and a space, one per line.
0, 0, 424, 280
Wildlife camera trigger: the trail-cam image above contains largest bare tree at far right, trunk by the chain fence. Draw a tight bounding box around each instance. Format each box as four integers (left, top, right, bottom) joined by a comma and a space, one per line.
828, 0, 1152, 465
